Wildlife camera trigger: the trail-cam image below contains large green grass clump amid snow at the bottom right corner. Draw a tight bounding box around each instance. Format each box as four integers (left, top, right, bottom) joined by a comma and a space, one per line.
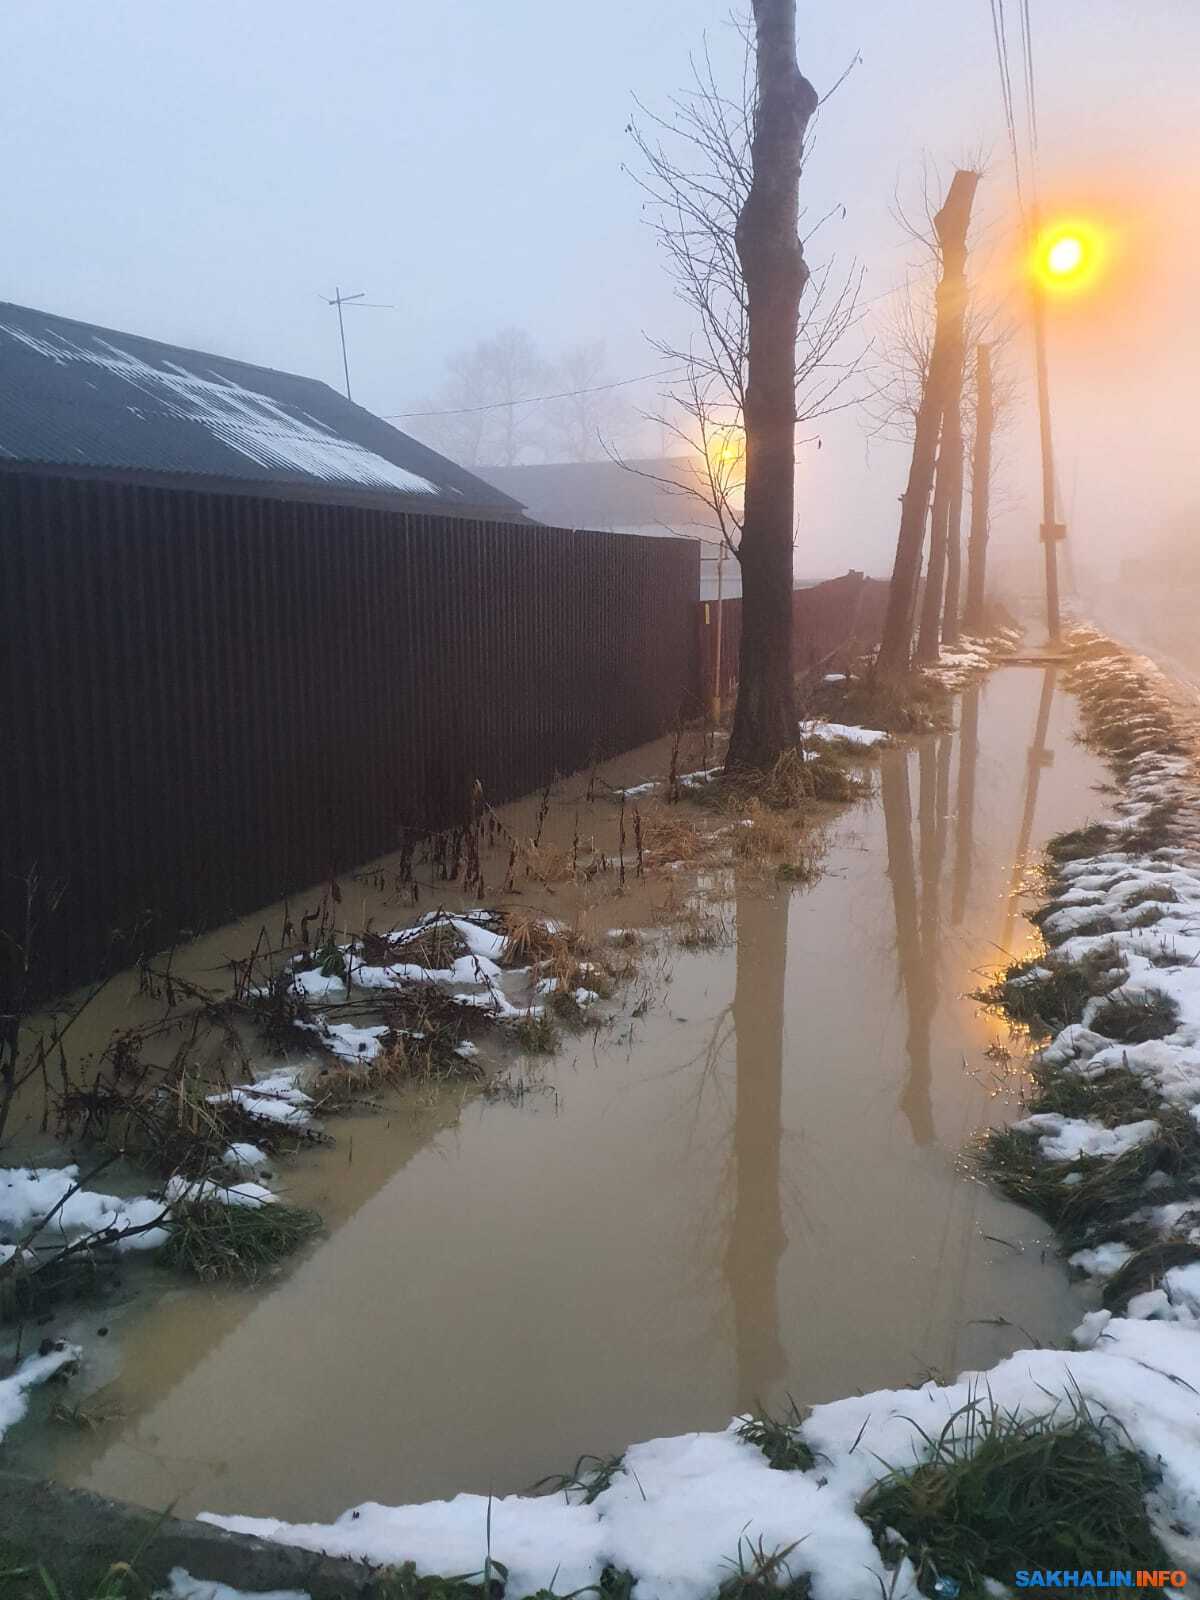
859, 1394, 1171, 1600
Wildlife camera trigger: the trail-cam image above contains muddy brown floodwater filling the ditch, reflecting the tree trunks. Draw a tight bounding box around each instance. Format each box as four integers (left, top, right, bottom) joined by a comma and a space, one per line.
13, 667, 1102, 1520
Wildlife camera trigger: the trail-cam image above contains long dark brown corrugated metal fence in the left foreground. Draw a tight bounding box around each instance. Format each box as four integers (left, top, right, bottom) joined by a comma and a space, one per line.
0, 474, 699, 989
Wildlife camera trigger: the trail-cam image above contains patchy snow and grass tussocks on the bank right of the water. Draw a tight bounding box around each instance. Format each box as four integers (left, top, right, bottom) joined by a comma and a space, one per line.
984, 629, 1200, 1328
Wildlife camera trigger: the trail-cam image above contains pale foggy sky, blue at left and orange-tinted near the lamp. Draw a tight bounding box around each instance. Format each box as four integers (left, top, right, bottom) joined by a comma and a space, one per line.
0, 0, 1200, 592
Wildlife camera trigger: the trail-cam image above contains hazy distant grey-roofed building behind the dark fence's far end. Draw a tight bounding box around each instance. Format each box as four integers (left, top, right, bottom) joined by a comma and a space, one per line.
486, 456, 742, 600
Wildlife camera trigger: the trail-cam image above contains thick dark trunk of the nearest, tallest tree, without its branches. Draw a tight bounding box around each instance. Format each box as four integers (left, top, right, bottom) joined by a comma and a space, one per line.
726, 0, 818, 768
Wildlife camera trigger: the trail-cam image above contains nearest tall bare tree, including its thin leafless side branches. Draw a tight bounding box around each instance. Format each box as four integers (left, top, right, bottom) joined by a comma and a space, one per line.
632, 0, 861, 766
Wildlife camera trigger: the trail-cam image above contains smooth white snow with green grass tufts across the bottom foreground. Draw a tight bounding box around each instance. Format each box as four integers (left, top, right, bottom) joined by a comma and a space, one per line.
195, 1310, 1200, 1600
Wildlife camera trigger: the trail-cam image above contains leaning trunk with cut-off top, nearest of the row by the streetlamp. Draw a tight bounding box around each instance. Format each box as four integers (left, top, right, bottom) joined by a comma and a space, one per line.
878, 171, 979, 672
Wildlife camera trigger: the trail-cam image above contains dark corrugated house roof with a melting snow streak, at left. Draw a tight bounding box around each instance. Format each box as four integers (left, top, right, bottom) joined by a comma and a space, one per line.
0, 302, 520, 518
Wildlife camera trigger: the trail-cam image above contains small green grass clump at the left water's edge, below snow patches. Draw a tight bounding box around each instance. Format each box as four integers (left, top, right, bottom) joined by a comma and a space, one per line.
162, 1200, 322, 1283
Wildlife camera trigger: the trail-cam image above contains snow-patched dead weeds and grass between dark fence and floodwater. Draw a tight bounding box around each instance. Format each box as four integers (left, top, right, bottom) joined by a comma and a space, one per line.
0, 910, 640, 1318
